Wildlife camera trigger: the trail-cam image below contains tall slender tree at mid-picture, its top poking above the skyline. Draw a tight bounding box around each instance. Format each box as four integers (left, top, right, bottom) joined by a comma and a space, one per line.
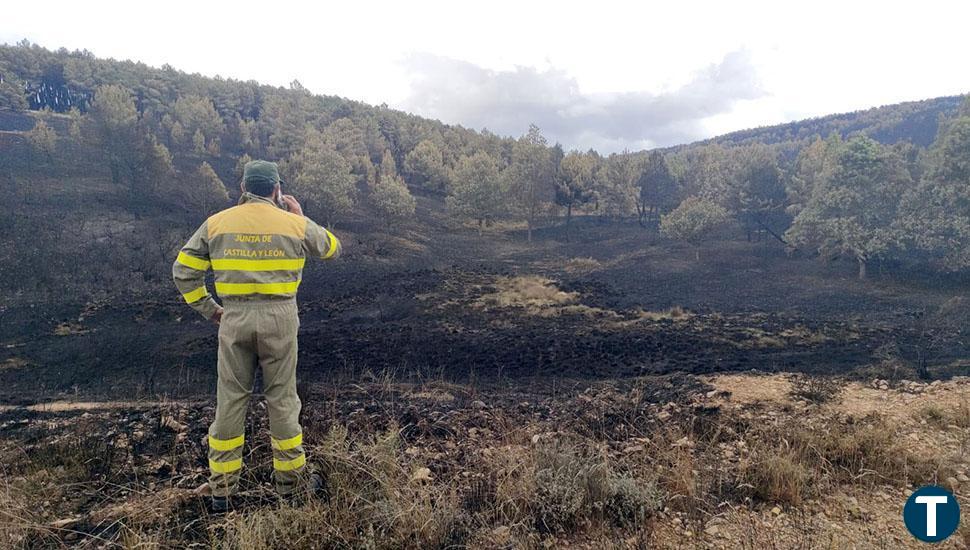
506, 128, 554, 242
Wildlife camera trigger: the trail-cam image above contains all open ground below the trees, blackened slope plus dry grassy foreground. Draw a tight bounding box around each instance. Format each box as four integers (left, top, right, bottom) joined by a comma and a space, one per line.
0, 220, 970, 548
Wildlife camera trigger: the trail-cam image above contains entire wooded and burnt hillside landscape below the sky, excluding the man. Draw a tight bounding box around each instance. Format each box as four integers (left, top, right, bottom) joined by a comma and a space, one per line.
0, 44, 970, 550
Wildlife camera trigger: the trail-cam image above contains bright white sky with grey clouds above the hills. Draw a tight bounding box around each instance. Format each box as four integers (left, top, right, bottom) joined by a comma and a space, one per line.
0, 0, 970, 153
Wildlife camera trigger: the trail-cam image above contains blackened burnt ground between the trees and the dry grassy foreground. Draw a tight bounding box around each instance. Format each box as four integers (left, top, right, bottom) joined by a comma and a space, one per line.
0, 222, 966, 403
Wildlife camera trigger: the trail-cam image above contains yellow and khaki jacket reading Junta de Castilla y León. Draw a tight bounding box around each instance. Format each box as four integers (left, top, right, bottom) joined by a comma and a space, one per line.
172, 193, 340, 319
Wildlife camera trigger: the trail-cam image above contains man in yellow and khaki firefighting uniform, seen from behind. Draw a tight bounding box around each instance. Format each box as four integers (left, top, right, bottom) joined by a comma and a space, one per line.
172, 160, 340, 512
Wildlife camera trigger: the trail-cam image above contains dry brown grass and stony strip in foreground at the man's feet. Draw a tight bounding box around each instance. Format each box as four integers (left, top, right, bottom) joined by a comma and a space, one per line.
0, 376, 970, 549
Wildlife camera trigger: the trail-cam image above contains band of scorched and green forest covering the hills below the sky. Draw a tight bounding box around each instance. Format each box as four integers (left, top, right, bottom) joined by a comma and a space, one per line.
0, 42, 970, 291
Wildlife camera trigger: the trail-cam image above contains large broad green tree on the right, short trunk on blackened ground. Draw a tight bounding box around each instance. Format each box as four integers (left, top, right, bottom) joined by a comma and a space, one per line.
786, 137, 910, 279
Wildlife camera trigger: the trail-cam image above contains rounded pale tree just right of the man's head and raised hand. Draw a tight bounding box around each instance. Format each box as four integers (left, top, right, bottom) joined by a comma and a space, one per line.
289, 129, 357, 225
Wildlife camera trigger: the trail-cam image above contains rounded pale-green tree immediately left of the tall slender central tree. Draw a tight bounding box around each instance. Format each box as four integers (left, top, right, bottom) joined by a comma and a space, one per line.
446, 151, 505, 235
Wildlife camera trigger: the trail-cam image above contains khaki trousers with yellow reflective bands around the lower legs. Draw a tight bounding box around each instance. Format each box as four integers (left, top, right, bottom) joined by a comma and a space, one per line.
209, 299, 306, 496
